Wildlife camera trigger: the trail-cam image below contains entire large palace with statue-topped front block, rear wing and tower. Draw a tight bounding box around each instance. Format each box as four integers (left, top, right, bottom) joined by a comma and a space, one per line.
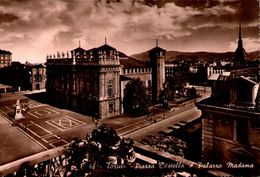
46, 43, 165, 118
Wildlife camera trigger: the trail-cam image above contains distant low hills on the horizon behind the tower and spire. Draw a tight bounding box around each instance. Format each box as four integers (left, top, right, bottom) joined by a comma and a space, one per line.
131, 51, 259, 62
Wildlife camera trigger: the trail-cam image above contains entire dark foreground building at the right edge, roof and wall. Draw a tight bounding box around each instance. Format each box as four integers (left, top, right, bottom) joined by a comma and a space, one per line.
197, 68, 260, 175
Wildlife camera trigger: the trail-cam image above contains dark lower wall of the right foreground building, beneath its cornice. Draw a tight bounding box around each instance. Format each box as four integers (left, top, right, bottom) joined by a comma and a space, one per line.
201, 107, 260, 167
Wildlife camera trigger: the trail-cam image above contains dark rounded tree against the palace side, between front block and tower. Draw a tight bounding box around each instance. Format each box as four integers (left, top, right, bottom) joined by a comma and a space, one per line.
123, 78, 151, 114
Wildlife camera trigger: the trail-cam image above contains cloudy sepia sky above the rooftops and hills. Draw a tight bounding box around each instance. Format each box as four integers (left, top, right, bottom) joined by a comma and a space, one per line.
0, 0, 260, 63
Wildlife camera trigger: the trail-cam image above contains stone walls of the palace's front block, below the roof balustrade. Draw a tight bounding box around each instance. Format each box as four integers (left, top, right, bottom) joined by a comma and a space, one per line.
47, 66, 120, 118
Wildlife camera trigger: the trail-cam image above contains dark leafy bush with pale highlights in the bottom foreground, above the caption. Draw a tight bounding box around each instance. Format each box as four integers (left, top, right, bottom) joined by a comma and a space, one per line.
65, 124, 136, 176
